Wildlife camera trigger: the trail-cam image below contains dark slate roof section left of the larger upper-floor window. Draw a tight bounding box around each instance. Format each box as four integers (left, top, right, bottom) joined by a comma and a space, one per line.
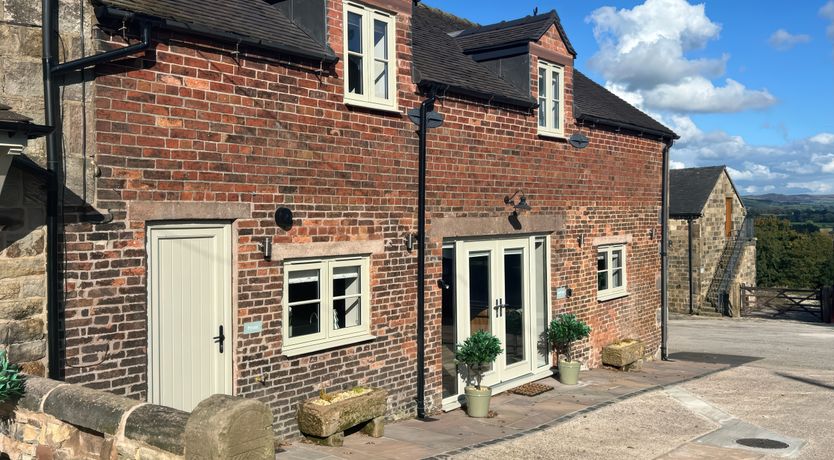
95, 0, 336, 60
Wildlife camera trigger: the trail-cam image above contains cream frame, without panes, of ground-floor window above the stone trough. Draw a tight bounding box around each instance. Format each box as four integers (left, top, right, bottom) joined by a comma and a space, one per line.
281, 256, 374, 356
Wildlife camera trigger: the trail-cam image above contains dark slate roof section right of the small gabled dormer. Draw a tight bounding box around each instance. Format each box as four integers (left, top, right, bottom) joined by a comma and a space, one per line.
573, 70, 678, 139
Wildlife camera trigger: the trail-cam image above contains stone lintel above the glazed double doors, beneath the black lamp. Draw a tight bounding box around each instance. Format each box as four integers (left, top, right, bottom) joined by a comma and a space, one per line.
428, 212, 565, 240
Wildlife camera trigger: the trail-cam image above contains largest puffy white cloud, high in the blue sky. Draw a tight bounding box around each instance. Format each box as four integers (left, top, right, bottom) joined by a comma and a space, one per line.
586, 0, 772, 113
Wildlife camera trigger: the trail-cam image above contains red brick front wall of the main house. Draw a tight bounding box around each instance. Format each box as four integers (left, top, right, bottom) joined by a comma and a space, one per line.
60, 1, 662, 436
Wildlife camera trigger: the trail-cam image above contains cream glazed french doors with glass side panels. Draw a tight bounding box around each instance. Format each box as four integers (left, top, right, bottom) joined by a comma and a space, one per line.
444, 236, 550, 399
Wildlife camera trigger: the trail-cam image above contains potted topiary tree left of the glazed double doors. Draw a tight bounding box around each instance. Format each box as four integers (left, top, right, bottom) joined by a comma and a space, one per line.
455, 331, 504, 417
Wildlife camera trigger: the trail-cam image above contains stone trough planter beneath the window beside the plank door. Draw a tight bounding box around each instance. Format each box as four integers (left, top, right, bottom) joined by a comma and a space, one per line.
296, 388, 388, 447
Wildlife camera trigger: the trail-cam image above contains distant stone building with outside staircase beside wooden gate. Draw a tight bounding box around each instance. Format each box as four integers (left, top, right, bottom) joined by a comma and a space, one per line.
669, 166, 756, 316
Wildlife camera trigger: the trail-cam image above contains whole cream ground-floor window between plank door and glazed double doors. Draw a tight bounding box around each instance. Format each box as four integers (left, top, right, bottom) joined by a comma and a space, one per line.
283, 257, 373, 356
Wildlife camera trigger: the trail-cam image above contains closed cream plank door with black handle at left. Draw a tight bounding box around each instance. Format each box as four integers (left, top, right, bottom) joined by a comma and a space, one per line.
148, 223, 233, 411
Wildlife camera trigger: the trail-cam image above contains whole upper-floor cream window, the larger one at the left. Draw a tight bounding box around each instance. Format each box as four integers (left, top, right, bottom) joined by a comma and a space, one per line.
344, 2, 397, 110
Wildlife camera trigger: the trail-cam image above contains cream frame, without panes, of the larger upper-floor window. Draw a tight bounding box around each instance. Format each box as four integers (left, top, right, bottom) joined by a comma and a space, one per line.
342, 2, 398, 111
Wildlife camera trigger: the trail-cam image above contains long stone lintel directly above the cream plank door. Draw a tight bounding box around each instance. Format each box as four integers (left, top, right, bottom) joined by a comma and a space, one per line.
127, 201, 252, 221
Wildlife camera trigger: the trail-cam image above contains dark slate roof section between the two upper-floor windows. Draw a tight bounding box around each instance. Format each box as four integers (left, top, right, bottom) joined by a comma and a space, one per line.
411, 4, 535, 106
